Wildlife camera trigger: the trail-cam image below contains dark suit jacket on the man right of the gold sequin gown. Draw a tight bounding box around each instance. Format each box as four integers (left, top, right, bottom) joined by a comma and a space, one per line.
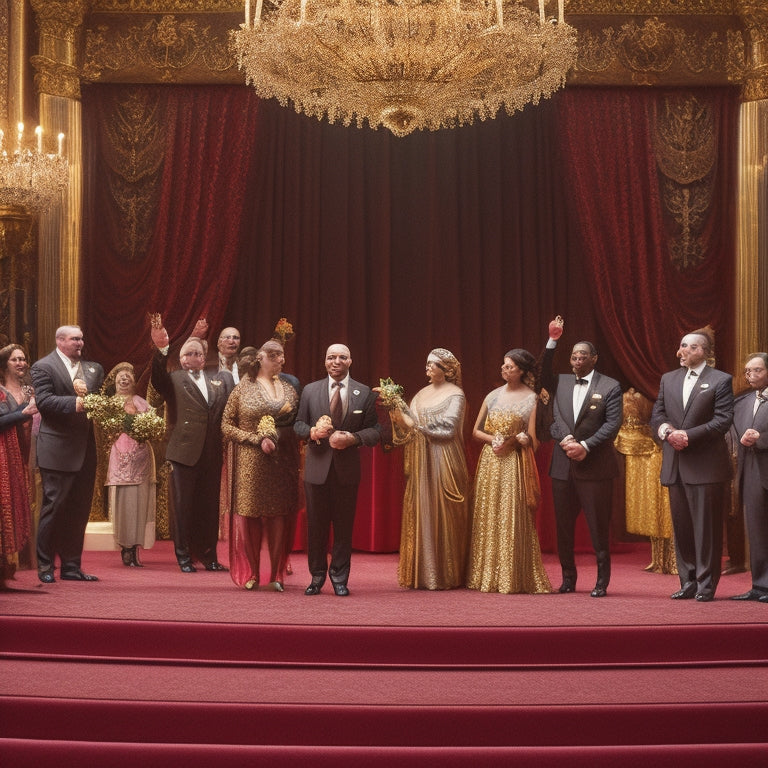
549, 371, 622, 480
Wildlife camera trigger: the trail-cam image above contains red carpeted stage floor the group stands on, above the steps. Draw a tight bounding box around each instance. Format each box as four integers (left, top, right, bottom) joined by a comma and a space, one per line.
0, 541, 768, 627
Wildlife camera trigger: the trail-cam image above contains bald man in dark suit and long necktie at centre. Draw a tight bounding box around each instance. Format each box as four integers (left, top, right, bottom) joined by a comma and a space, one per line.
294, 344, 380, 597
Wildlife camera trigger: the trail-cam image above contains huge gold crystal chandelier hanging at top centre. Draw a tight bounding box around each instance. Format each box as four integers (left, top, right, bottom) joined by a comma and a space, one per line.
231, 0, 577, 136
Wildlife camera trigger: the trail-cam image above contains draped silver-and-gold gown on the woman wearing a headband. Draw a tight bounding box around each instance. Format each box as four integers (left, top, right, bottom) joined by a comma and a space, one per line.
392, 392, 469, 589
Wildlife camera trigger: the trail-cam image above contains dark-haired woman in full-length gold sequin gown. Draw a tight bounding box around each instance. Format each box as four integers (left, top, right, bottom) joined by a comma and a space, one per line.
467, 349, 552, 594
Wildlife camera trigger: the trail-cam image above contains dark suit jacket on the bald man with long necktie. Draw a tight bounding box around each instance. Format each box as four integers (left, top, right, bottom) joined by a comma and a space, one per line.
293, 377, 381, 485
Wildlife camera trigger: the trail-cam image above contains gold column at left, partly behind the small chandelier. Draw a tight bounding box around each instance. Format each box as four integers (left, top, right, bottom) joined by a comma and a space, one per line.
31, 0, 88, 353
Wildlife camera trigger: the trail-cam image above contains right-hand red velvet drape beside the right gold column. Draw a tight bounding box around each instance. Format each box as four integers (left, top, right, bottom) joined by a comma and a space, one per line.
557, 88, 738, 399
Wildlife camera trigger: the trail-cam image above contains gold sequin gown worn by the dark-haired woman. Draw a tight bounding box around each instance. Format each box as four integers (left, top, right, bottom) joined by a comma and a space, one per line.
467, 393, 552, 594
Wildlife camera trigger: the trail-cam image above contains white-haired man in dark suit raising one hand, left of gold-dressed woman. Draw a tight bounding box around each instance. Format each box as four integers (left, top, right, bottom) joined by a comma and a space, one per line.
151, 316, 234, 573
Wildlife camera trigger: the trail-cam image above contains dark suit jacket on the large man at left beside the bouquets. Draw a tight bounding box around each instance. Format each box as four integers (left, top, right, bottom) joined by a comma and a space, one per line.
30, 351, 104, 472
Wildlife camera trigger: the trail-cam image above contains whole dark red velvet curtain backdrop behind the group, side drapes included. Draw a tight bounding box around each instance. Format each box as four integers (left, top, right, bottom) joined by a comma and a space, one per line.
80, 86, 737, 550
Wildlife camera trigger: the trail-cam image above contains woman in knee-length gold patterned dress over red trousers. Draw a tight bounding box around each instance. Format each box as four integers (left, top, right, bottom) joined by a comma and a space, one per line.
221, 339, 300, 592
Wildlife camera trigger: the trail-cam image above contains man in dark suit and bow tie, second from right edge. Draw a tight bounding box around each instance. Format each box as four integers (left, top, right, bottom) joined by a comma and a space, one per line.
651, 329, 733, 602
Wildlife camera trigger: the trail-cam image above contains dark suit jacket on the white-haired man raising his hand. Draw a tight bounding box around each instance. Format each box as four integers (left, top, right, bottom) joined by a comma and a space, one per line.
152, 351, 235, 467
